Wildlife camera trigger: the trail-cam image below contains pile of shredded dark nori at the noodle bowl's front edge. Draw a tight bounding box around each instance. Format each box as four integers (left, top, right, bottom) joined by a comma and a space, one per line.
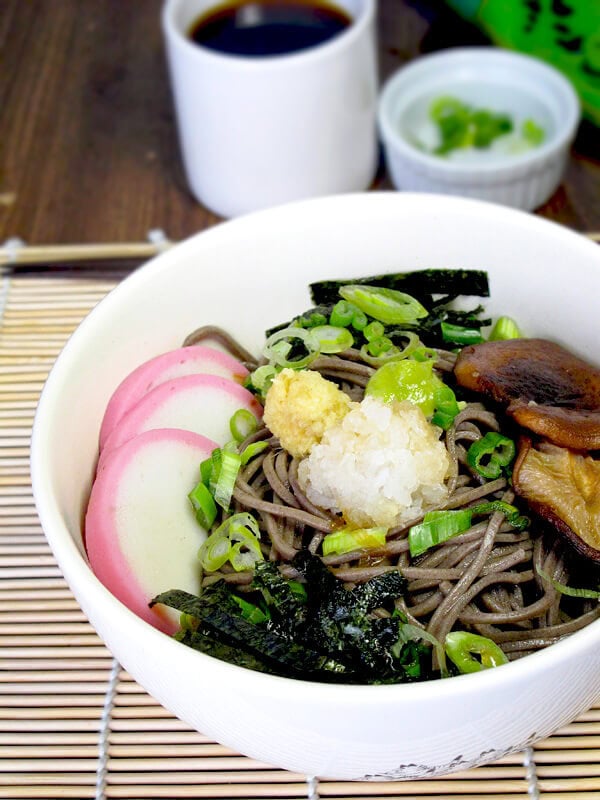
152, 550, 428, 683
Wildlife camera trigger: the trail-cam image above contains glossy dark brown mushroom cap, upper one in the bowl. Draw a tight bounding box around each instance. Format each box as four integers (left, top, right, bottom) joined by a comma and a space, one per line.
454, 339, 600, 450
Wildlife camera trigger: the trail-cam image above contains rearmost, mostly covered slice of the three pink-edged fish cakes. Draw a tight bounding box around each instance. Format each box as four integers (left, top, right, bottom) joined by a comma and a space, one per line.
100, 345, 248, 449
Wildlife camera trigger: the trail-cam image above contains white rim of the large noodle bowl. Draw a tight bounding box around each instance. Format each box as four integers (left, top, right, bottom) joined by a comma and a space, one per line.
31, 191, 600, 705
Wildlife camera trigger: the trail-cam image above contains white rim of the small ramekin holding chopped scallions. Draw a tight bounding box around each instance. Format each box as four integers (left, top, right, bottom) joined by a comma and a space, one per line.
377, 46, 581, 181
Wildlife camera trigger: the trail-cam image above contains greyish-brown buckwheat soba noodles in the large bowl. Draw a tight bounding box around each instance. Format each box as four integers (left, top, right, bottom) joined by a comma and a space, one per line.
185, 327, 600, 659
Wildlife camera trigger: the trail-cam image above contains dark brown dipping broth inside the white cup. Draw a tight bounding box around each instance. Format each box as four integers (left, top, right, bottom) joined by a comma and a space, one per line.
189, 0, 352, 57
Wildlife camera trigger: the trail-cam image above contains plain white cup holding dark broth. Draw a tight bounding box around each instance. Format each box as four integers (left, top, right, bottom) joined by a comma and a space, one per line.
162, 0, 377, 217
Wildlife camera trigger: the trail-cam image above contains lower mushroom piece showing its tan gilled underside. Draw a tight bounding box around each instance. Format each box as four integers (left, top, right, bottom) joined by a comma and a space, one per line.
513, 439, 600, 563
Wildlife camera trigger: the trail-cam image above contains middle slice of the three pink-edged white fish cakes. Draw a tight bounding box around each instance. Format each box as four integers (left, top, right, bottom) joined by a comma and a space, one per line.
99, 375, 263, 464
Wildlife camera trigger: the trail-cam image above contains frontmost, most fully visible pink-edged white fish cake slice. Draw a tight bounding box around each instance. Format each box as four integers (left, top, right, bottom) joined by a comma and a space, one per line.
85, 429, 217, 634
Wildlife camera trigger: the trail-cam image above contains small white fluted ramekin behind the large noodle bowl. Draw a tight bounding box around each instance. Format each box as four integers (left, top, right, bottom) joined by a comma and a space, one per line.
378, 47, 580, 211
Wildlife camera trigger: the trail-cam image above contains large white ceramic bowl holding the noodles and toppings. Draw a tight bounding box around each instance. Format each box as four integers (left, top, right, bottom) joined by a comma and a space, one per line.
32, 192, 600, 779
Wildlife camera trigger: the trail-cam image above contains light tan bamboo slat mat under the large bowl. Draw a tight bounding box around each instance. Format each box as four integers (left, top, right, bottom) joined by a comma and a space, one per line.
0, 251, 600, 800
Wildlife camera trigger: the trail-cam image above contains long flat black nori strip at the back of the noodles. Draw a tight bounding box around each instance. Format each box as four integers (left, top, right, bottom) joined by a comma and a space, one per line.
309, 269, 490, 307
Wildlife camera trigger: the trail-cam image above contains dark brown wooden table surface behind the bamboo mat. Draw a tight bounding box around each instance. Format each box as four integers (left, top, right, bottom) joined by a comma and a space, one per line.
0, 0, 600, 244
